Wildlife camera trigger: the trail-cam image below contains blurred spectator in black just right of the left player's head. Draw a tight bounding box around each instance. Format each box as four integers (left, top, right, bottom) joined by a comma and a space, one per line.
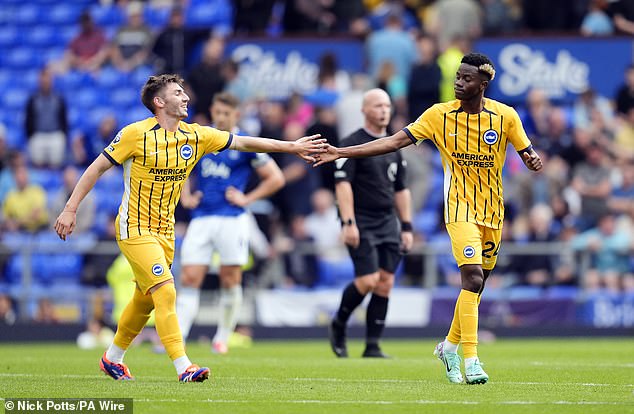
187, 37, 225, 125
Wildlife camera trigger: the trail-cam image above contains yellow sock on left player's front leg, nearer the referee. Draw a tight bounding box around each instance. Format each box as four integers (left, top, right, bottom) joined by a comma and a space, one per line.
152, 283, 185, 361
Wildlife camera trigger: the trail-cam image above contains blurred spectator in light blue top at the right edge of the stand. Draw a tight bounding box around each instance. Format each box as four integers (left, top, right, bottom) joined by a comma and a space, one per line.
571, 213, 631, 292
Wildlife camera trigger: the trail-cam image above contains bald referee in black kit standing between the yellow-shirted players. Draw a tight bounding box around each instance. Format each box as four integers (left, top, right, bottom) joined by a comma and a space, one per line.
329, 89, 413, 358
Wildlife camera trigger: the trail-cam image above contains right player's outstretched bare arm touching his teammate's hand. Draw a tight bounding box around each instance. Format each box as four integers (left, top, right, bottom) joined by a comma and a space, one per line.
314, 131, 412, 167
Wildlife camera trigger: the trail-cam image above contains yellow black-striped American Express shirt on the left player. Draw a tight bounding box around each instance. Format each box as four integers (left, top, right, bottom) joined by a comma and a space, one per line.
103, 118, 233, 240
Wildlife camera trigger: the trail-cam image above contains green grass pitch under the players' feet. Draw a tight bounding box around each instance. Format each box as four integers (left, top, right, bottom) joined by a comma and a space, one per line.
0, 338, 634, 414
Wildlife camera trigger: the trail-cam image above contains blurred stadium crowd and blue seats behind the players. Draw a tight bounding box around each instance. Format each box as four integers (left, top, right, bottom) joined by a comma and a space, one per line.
0, 0, 634, 322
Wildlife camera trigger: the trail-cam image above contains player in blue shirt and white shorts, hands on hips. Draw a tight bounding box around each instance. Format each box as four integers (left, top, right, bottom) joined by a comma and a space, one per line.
176, 93, 284, 354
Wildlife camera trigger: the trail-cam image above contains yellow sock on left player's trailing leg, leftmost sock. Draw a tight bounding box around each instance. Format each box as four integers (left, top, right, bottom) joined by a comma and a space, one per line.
113, 287, 154, 349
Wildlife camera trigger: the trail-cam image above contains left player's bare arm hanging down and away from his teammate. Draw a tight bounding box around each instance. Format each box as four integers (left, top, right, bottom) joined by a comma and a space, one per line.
55, 154, 113, 240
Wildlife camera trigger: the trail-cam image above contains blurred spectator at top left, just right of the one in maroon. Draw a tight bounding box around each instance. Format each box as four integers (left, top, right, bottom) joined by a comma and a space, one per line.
110, 1, 154, 72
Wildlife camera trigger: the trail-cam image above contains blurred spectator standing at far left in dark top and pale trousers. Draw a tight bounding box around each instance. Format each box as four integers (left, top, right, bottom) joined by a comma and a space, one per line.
25, 68, 68, 168
